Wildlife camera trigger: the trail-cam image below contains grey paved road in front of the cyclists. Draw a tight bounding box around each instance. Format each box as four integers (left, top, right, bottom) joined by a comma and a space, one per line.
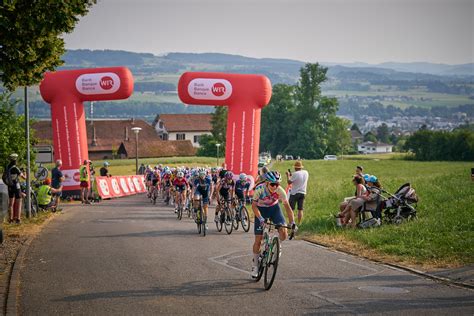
19, 195, 474, 315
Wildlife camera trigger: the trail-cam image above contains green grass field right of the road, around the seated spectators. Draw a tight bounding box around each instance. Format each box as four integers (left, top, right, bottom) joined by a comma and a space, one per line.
274, 160, 474, 267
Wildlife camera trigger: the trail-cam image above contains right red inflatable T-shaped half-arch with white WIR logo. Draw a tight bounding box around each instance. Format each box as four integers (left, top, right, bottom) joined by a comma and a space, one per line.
178, 72, 272, 183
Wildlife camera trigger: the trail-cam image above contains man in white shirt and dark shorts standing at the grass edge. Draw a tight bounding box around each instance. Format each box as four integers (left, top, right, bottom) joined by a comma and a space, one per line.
286, 161, 309, 225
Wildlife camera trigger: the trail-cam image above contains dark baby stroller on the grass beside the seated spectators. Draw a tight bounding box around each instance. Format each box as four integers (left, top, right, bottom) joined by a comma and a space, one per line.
382, 183, 418, 225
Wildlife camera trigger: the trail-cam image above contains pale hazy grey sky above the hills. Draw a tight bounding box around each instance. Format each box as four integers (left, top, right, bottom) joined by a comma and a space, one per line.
64, 0, 474, 64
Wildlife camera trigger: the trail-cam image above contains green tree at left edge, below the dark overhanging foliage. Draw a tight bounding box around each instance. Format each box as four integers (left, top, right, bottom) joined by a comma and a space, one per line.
0, 92, 36, 168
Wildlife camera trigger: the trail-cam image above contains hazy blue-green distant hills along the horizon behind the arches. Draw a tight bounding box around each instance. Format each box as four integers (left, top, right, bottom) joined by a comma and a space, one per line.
10, 49, 474, 120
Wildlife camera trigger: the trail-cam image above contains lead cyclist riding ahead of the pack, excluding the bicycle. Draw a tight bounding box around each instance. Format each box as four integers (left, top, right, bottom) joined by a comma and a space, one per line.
252, 171, 297, 278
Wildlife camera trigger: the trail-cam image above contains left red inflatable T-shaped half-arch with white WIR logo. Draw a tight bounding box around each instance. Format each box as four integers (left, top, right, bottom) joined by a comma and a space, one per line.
40, 67, 133, 191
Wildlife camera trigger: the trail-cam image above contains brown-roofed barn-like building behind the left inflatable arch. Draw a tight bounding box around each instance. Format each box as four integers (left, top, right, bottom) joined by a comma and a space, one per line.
32, 119, 196, 160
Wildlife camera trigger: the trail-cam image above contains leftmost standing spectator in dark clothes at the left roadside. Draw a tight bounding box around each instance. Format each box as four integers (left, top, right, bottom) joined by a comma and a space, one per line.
5, 153, 26, 224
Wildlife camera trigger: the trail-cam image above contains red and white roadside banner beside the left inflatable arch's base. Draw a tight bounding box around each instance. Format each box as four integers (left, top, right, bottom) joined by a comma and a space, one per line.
96, 175, 146, 199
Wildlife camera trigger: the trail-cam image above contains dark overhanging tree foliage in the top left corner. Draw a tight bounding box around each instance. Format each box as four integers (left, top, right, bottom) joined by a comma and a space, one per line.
0, 0, 96, 91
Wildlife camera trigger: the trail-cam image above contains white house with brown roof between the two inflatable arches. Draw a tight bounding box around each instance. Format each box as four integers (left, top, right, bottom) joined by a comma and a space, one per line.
153, 114, 212, 147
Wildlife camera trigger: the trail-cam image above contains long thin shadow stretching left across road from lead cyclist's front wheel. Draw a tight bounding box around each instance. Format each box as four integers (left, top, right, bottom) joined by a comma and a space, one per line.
54, 280, 264, 302
